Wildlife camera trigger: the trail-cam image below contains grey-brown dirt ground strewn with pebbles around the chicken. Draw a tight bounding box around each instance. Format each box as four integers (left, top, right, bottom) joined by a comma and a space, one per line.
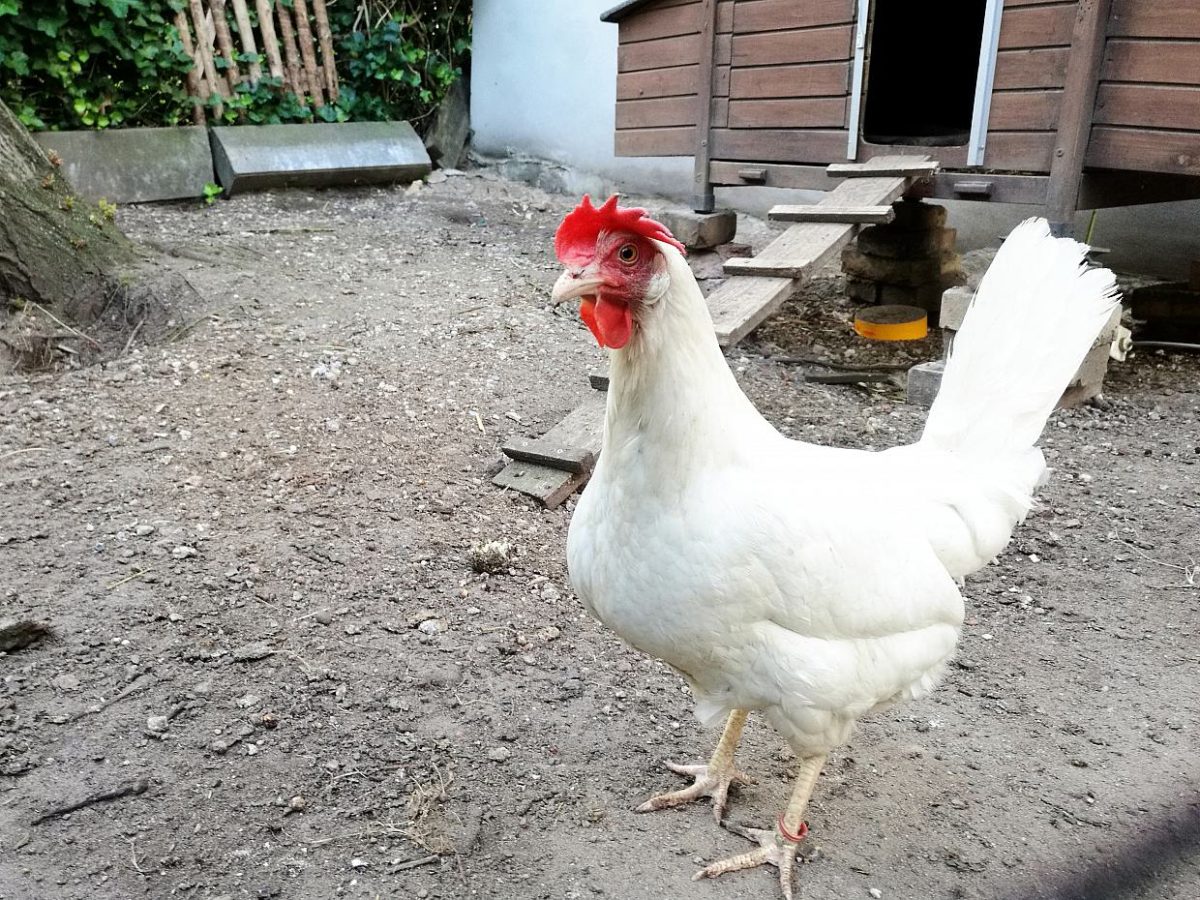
0, 173, 1200, 900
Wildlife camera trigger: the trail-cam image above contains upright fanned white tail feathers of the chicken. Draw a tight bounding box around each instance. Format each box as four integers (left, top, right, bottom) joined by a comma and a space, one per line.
922, 218, 1120, 454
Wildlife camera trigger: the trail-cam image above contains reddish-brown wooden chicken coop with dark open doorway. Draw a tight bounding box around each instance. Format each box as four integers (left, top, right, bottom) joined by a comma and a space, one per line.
601, 0, 1200, 224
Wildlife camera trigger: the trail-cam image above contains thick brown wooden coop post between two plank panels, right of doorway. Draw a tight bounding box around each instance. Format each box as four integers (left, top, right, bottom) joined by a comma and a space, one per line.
1045, 0, 1112, 234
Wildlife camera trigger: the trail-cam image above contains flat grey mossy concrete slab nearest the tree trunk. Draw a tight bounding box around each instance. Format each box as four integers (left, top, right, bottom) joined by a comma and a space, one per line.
34, 127, 212, 203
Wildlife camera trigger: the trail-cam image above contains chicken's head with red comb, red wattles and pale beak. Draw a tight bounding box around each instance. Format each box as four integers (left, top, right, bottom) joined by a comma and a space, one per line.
553, 194, 685, 349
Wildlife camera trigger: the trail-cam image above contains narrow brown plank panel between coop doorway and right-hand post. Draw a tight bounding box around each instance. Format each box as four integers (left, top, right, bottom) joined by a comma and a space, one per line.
984, 0, 1076, 172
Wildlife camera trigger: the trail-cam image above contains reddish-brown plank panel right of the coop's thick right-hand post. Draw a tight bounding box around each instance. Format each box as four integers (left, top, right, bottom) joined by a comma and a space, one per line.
1085, 0, 1200, 175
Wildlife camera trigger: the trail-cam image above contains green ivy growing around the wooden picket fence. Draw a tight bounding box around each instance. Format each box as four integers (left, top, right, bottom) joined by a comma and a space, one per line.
0, 0, 470, 131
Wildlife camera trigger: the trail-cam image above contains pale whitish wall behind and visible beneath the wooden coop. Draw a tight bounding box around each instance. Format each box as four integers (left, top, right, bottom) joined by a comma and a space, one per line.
470, 0, 1200, 277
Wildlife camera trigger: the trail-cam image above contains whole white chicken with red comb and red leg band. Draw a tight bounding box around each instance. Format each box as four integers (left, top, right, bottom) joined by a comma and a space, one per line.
553, 197, 1118, 899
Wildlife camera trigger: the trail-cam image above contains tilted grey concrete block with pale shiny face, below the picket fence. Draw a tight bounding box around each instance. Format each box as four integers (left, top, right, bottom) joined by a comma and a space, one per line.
210, 122, 432, 194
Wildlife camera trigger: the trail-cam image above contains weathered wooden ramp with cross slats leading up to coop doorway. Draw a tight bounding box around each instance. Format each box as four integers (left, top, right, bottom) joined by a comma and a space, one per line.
492, 156, 937, 509
